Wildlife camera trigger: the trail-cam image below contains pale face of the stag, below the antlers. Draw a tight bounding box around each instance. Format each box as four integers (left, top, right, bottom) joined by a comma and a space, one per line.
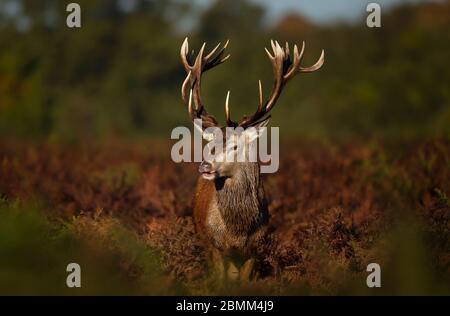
198, 119, 268, 180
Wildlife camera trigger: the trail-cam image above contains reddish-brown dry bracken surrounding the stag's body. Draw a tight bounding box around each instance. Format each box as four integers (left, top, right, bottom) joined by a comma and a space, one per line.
0, 140, 450, 294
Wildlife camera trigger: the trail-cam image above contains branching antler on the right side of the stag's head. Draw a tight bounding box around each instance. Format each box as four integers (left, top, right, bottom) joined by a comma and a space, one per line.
239, 41, 325, 128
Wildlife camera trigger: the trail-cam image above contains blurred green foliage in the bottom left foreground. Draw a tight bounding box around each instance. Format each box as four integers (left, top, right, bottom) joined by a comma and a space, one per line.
0, 200, 178, 295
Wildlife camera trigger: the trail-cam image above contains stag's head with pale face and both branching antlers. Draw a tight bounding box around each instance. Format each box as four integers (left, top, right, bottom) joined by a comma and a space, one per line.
180, 38, 324, 180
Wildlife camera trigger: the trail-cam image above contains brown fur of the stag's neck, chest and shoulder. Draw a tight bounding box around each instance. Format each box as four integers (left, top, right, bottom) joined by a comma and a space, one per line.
194, 162, 268, 256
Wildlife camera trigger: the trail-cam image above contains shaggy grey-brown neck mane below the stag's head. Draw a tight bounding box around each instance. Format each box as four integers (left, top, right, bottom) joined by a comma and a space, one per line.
215, 162, 263, 234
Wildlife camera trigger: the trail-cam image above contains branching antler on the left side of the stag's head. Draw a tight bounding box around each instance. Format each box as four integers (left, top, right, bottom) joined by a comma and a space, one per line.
180, 37, 230, 128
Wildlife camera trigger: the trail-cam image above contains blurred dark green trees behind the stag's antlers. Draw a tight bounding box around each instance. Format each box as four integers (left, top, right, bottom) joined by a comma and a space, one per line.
0, 0, 450, 141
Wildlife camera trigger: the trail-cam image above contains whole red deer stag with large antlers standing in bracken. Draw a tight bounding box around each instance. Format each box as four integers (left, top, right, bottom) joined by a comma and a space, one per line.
181, 38, 324, 280
